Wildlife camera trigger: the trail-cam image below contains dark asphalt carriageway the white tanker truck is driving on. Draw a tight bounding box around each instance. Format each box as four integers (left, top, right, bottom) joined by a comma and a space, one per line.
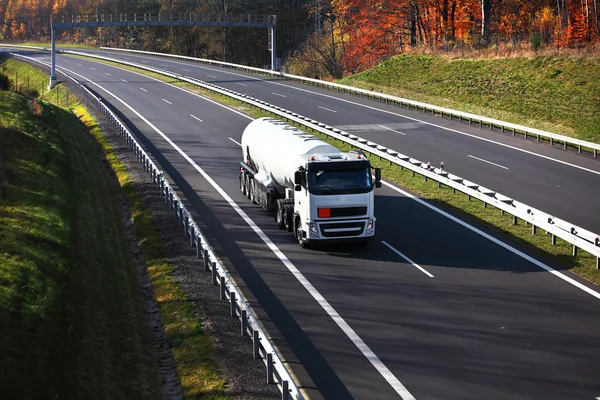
15, 50, 600, 399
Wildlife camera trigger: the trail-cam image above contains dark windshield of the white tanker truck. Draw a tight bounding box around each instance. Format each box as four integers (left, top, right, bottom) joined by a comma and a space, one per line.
308, 168, 373, 195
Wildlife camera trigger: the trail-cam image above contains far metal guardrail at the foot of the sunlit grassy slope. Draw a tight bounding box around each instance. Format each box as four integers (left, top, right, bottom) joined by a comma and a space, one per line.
101, 47, 600, 158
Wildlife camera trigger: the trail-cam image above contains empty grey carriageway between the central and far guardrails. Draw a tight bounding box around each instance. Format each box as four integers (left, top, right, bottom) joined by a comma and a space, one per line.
72, 51, 600, 232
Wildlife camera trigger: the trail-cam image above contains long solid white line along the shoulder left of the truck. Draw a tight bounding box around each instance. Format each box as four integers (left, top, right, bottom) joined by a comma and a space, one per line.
47, 59, 415, 400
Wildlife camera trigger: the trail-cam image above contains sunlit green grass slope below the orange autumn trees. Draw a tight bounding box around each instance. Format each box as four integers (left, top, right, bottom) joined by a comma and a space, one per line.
337, 54, 600, 143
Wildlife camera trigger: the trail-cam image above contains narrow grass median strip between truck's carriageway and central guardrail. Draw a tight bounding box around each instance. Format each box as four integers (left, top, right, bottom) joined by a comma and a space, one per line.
70, 54, 600, 284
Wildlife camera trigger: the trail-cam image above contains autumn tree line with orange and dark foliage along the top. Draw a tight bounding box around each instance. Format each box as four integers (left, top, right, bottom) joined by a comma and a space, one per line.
0, 0, 600, 78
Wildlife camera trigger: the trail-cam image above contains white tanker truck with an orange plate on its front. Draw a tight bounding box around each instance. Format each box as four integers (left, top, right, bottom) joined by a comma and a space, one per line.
239, 118, 381, 247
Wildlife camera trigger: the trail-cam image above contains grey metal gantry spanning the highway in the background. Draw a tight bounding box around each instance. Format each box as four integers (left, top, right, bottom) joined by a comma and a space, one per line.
50, 13, 277, 88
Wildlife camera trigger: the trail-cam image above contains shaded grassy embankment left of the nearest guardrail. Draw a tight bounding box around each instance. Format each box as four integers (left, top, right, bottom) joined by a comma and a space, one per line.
0, 59, 225, 399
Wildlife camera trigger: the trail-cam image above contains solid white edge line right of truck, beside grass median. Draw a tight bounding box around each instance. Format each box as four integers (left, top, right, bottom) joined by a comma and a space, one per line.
382, 181, 600, 299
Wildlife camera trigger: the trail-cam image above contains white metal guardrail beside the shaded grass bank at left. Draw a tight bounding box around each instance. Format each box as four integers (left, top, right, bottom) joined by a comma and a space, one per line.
7, 54, 305, 400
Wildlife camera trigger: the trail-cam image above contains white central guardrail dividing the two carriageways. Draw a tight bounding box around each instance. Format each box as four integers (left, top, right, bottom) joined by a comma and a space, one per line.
3, 48, 600, 269
